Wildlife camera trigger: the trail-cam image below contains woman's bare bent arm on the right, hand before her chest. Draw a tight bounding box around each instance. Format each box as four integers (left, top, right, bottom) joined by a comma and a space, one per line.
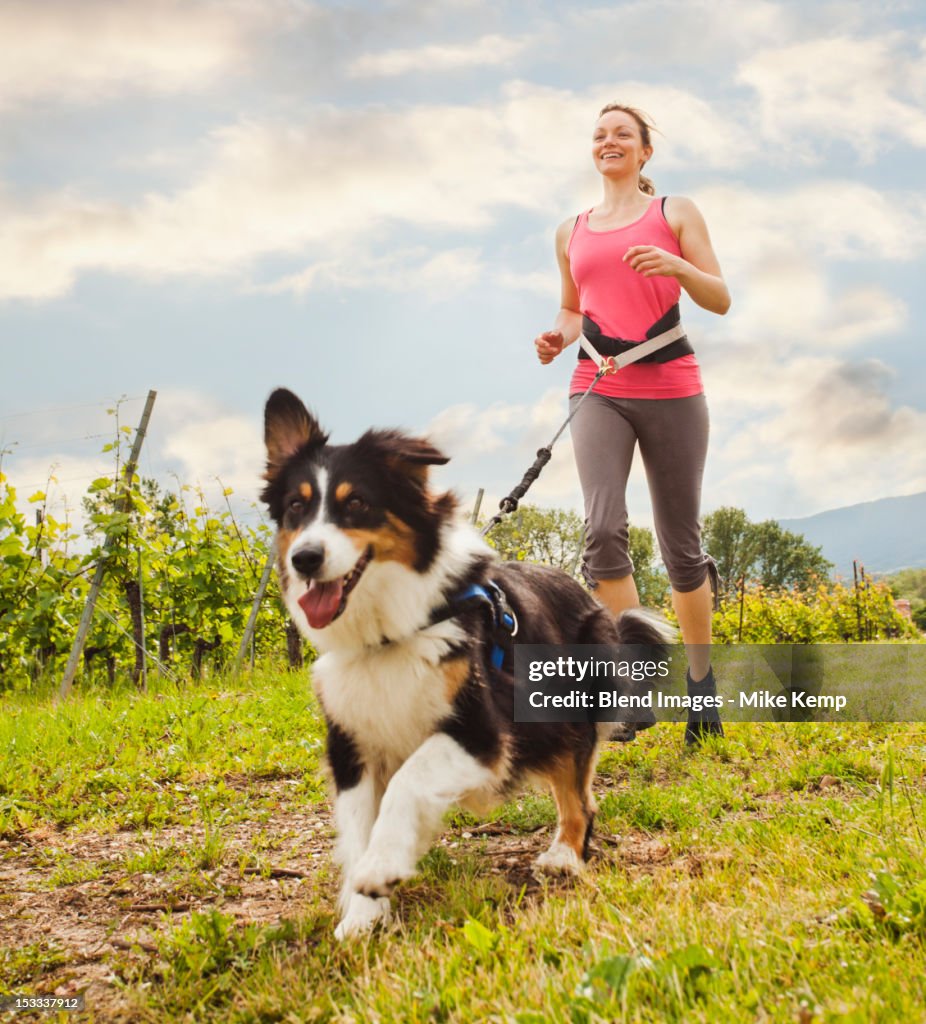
624, 196, 730, 314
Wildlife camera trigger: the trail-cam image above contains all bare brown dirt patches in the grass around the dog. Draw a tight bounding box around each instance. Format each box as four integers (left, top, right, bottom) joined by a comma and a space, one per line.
0, 781, 688, 1022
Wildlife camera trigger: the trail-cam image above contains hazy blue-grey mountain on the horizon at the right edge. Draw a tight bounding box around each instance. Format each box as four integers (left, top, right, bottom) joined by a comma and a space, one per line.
778, 492, 926, 579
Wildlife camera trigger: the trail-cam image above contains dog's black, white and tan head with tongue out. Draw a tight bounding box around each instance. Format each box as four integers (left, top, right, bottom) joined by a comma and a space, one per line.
261, 388, 456, 630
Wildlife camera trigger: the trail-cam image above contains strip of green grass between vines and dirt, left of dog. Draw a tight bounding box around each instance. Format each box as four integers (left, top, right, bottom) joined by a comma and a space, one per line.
0, 673, 324, 838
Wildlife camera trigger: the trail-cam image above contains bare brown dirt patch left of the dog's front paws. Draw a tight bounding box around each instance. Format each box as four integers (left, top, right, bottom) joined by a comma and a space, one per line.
0, 783, 332, 1021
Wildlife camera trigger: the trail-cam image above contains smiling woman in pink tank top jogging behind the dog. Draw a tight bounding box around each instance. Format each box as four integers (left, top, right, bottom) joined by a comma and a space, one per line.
535, 103, 730, 744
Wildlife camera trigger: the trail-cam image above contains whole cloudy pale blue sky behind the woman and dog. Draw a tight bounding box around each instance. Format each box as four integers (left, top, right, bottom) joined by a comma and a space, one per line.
0, 0, 926, 544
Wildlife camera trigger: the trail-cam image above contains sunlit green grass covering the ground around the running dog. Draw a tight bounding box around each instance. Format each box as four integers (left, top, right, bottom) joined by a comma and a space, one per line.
0, 671, 926, 1024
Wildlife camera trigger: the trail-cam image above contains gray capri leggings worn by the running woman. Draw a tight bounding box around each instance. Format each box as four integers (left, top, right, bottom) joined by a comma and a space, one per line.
570, 392, 717, 593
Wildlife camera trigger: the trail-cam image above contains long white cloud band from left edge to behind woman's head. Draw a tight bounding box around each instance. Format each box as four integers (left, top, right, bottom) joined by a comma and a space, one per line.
0, 83, 766, 299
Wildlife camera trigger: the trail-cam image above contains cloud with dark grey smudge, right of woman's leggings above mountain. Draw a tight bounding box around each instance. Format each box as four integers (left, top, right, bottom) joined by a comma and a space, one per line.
705, 346, 926, 517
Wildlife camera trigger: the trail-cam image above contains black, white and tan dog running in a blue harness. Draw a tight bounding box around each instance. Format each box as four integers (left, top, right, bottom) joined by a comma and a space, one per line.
261, 388, 671, 939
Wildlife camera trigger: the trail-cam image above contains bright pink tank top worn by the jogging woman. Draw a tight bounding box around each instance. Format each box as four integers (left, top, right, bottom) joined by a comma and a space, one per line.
566, 199, 704, 398
